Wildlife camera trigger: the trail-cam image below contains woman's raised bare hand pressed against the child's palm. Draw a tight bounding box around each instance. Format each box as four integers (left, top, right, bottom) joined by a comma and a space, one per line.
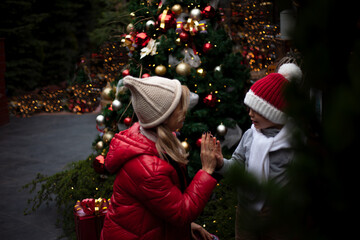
200, 133, 216, 174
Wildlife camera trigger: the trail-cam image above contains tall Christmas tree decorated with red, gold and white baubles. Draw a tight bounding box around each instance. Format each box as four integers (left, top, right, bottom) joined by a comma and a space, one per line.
94, 1, 249, 174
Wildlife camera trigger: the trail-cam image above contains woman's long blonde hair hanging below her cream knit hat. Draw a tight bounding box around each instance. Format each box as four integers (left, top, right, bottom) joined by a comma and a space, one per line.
155, 86, 190, 164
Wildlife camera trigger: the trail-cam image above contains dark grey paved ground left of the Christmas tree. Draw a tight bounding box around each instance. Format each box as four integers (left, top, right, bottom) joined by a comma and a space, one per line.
0, 113, 98, 240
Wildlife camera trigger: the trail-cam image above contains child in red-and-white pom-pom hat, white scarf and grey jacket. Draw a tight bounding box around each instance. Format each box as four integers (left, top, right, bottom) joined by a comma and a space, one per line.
217, 63, 302, 240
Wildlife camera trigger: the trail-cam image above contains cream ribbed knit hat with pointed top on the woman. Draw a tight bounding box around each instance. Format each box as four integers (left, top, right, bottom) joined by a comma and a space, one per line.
123, 76, 182, 128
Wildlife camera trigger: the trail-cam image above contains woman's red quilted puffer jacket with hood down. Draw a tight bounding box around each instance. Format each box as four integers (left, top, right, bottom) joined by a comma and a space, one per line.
101, 123, 216, 240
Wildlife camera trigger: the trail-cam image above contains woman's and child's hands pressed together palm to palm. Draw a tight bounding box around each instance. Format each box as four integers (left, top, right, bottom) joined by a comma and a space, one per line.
200, 132, 224, 174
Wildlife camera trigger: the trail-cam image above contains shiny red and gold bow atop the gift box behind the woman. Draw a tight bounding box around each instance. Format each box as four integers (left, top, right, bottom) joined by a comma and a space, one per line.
74, 198, 110, 216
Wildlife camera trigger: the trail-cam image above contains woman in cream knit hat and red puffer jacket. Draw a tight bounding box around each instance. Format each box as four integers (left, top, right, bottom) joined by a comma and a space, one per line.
101, 76, 217, 240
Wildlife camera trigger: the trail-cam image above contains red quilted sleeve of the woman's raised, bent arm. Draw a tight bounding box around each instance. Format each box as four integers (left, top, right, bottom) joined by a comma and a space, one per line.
126, 156, 217, 226
